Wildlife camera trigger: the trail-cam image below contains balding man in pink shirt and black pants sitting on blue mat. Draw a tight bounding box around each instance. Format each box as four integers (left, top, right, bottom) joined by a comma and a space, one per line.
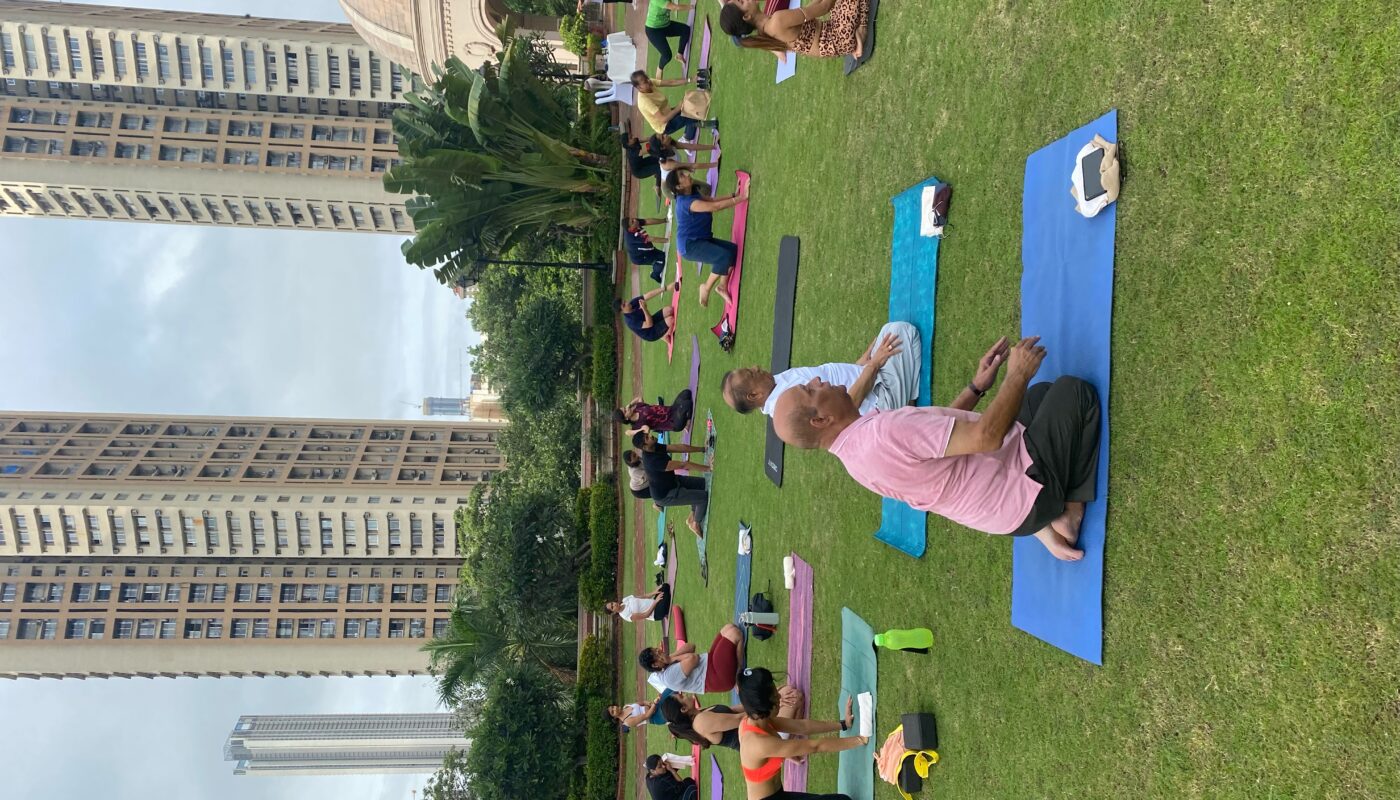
773, 336, 1099, 560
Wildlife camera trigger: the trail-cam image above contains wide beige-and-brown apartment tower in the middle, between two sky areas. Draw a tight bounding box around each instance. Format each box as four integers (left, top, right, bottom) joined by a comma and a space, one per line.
0, 413, 503, 677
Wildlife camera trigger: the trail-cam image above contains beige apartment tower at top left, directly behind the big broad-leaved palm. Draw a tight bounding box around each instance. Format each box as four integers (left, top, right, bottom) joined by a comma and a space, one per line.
0, 0, 413, 234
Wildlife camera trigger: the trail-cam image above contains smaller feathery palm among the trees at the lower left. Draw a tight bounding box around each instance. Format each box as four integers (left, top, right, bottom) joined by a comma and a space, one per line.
423, 600, 578, 706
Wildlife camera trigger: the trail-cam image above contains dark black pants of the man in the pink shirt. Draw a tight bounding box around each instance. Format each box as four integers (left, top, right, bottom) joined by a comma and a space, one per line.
1012, 375, 1099, 537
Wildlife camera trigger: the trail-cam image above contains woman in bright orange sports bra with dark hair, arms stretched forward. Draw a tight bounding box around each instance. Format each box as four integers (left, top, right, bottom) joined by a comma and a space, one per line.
739, 667, 869, 800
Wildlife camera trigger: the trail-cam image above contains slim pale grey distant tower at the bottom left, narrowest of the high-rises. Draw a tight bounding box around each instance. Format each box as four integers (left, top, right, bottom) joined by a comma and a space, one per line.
224, 713, 468, 775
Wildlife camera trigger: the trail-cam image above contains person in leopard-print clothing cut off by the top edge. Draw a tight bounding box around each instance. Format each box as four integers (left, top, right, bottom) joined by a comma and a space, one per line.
720, 0, 871, 60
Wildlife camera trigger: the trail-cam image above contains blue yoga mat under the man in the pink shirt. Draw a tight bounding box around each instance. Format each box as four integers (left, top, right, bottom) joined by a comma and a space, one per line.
1011, 111, 1119, 664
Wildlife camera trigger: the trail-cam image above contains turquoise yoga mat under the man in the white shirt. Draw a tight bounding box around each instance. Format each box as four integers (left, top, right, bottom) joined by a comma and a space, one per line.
875, 178, 939, 558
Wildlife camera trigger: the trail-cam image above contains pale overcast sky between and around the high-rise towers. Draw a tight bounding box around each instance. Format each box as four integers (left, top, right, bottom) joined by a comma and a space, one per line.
0, 0, 476, 800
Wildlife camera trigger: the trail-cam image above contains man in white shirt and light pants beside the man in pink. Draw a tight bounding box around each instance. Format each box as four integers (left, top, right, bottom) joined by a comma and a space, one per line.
720, 322, 924, 416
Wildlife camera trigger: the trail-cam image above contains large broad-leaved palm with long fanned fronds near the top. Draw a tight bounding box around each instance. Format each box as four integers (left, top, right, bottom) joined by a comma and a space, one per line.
384, 36, 616, 291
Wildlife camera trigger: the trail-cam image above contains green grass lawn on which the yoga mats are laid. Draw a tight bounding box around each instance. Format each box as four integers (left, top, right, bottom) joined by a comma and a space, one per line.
622, 0, 1400, 799
